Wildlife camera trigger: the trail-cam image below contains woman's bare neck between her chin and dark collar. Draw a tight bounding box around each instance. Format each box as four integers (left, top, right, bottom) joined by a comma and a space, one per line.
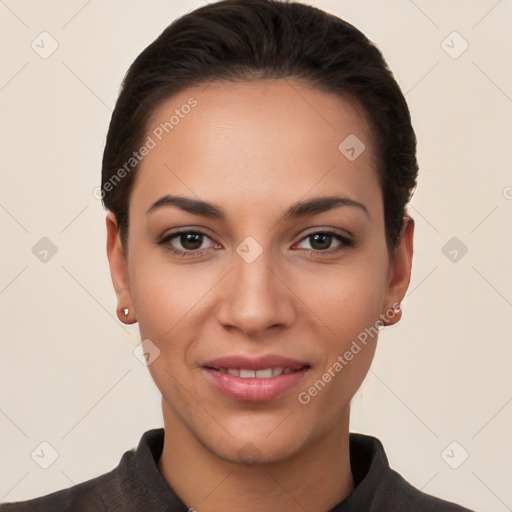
158, 401, 354, 512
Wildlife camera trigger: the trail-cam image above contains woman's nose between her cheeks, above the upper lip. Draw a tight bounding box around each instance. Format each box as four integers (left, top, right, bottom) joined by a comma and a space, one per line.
217, 249, 296, 337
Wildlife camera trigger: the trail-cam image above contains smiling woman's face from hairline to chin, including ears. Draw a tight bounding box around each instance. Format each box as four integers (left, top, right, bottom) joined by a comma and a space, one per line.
107, 80, 412, 462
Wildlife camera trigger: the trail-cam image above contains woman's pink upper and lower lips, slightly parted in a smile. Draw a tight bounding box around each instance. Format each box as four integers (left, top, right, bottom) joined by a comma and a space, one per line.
203, 354, 310, 402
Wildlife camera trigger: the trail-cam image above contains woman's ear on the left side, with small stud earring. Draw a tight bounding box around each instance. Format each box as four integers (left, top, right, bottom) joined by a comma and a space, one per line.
105, 211, 137, 324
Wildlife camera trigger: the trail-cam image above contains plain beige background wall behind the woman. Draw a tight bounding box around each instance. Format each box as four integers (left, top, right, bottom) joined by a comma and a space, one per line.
0, 0, 512, 512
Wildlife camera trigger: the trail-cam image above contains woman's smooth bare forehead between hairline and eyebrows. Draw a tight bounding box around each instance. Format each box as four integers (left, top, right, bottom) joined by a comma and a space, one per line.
132, 79, 380, 219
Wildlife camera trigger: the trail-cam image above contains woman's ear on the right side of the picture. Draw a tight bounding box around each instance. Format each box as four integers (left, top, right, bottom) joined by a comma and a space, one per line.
381, 216, 414, 326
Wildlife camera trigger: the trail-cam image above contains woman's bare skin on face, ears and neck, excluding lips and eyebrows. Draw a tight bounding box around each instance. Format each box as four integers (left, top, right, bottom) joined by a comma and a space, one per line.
106, 80, 414, 512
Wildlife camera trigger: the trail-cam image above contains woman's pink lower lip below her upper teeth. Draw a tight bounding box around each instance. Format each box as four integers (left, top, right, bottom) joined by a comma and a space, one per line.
205, 367, 308, 402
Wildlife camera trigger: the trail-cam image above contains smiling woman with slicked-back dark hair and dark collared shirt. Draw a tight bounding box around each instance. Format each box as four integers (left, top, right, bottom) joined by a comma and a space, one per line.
0, 0, 474, 512
